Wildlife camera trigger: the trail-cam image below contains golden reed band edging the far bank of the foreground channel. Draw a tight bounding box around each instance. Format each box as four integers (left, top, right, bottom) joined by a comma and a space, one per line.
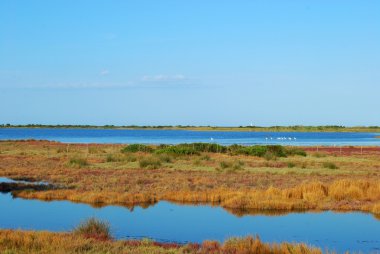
14, 179, 380, 214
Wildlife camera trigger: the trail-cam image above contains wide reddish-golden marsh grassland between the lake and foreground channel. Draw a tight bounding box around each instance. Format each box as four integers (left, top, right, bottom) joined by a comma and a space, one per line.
0, 141, 380, 213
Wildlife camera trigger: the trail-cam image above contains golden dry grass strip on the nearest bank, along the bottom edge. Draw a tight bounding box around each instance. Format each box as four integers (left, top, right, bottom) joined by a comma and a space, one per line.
0, 230, 322, 254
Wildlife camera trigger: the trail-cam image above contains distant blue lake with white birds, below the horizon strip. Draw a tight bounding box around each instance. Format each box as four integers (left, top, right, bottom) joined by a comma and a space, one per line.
0, 128, 380, 146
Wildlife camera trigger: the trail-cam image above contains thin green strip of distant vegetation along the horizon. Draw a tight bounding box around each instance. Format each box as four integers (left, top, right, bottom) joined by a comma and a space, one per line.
0, 124, 380, 132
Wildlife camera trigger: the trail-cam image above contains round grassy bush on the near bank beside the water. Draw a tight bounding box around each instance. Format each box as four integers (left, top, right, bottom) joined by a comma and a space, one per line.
73, 218, 112, 240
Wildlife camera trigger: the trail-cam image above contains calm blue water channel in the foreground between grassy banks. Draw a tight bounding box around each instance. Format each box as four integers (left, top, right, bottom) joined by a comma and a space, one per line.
0, 191, 380, 253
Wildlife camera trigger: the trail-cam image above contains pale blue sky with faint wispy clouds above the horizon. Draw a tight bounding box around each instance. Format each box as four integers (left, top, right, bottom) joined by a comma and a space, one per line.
0, 0, 380, 126
